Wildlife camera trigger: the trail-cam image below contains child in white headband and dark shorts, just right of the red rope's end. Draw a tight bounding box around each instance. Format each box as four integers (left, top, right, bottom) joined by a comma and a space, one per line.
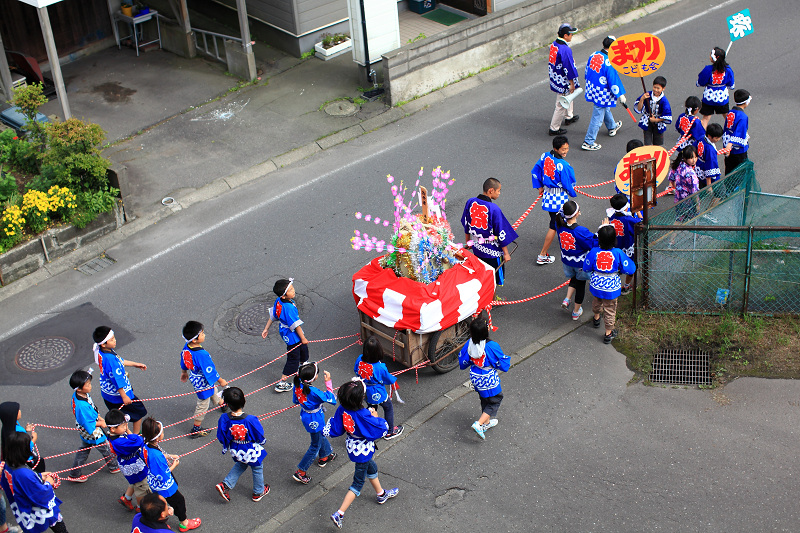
556, 200, 597, 320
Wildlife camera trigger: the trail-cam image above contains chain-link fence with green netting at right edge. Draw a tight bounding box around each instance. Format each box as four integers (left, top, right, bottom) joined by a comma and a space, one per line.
638, 162, 800, 314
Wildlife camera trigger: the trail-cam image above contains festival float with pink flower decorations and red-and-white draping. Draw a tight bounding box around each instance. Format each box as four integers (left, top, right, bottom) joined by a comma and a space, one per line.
351, 167, 495, 373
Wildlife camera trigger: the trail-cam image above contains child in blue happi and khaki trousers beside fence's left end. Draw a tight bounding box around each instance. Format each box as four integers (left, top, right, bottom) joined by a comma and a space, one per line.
583, 219, 636, 344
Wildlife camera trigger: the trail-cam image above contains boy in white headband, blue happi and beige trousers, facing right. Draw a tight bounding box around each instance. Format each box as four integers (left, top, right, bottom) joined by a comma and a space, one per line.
180, 320, 228, 439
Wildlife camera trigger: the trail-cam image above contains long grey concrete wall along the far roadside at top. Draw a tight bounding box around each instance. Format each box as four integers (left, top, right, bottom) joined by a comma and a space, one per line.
383, 0, 640, 105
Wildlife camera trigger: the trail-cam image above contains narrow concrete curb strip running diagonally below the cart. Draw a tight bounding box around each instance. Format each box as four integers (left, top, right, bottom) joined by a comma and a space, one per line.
252, 313, 591, 533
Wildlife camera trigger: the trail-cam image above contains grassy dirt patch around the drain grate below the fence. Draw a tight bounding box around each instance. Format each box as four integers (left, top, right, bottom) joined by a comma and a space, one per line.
614, 298, 800, 385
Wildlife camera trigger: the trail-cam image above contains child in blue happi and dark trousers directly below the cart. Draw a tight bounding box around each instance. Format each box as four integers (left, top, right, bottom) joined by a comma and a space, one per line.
353, 337, 403, 440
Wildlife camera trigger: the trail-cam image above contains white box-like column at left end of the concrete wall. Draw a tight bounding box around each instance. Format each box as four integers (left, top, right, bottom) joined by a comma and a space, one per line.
347, 0, 400, 65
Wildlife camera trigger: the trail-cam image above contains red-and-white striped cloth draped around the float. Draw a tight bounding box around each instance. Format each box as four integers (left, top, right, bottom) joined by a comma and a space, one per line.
353, 250, 495, 333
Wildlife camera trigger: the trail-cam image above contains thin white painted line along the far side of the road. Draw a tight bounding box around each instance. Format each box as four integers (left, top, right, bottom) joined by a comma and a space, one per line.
0, 0, 739, 341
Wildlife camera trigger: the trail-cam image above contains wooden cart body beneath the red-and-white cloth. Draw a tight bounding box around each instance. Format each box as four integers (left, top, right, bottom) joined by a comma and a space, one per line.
358, 311, 472, 374
